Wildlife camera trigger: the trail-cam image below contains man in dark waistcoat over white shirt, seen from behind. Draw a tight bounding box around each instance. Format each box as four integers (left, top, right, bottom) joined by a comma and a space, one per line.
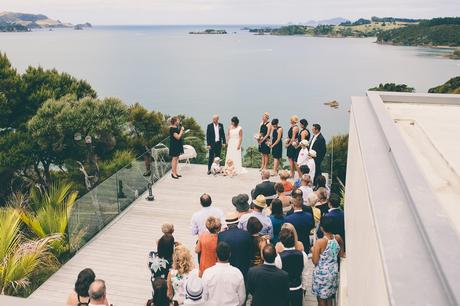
275, 229, 309, 306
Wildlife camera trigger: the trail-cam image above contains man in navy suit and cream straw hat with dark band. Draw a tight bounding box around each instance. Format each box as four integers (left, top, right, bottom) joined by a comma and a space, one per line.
218, 212, 252, 279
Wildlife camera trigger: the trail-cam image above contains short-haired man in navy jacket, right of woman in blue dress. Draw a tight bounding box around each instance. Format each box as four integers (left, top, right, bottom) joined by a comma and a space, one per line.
285, 189, 315, 254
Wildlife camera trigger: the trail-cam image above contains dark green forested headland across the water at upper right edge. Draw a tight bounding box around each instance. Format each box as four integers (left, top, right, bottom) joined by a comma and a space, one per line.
377, 17, 460, 46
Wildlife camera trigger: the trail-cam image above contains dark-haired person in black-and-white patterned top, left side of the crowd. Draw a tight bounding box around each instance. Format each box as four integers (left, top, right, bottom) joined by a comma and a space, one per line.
149, 234, 175, 280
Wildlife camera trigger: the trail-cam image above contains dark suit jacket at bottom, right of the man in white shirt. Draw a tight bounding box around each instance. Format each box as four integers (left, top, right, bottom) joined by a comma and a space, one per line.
246, 264, 289, 306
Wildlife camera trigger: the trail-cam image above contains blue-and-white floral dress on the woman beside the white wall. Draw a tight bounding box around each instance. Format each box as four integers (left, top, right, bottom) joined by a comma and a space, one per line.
312, 236, 340, 300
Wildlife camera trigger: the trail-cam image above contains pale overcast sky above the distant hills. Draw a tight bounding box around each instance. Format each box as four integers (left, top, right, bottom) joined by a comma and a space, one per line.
0, 0, 460, 25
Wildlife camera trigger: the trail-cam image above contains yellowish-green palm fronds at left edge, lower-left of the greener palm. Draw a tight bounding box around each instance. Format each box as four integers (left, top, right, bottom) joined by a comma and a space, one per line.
0, 207, 59, 294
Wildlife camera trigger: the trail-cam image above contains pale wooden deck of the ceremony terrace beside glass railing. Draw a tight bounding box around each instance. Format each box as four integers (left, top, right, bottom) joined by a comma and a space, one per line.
30, 165, 316, 306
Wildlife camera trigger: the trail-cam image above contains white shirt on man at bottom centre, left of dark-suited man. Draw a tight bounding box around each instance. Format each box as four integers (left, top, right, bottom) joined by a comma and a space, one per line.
202, 262, 246, 306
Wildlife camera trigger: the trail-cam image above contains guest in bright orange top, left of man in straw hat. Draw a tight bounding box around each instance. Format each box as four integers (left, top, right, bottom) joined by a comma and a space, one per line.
195, 216, 221, 277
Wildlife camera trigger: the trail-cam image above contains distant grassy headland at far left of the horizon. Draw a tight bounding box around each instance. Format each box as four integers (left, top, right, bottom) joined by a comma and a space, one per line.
0, 12, 91, 32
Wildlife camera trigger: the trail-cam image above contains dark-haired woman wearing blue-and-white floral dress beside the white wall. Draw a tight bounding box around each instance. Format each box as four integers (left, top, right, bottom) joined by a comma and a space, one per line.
311, 216, 344, 306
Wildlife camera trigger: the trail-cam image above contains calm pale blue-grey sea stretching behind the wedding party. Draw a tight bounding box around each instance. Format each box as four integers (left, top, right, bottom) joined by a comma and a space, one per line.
0, 26, 460, 145
